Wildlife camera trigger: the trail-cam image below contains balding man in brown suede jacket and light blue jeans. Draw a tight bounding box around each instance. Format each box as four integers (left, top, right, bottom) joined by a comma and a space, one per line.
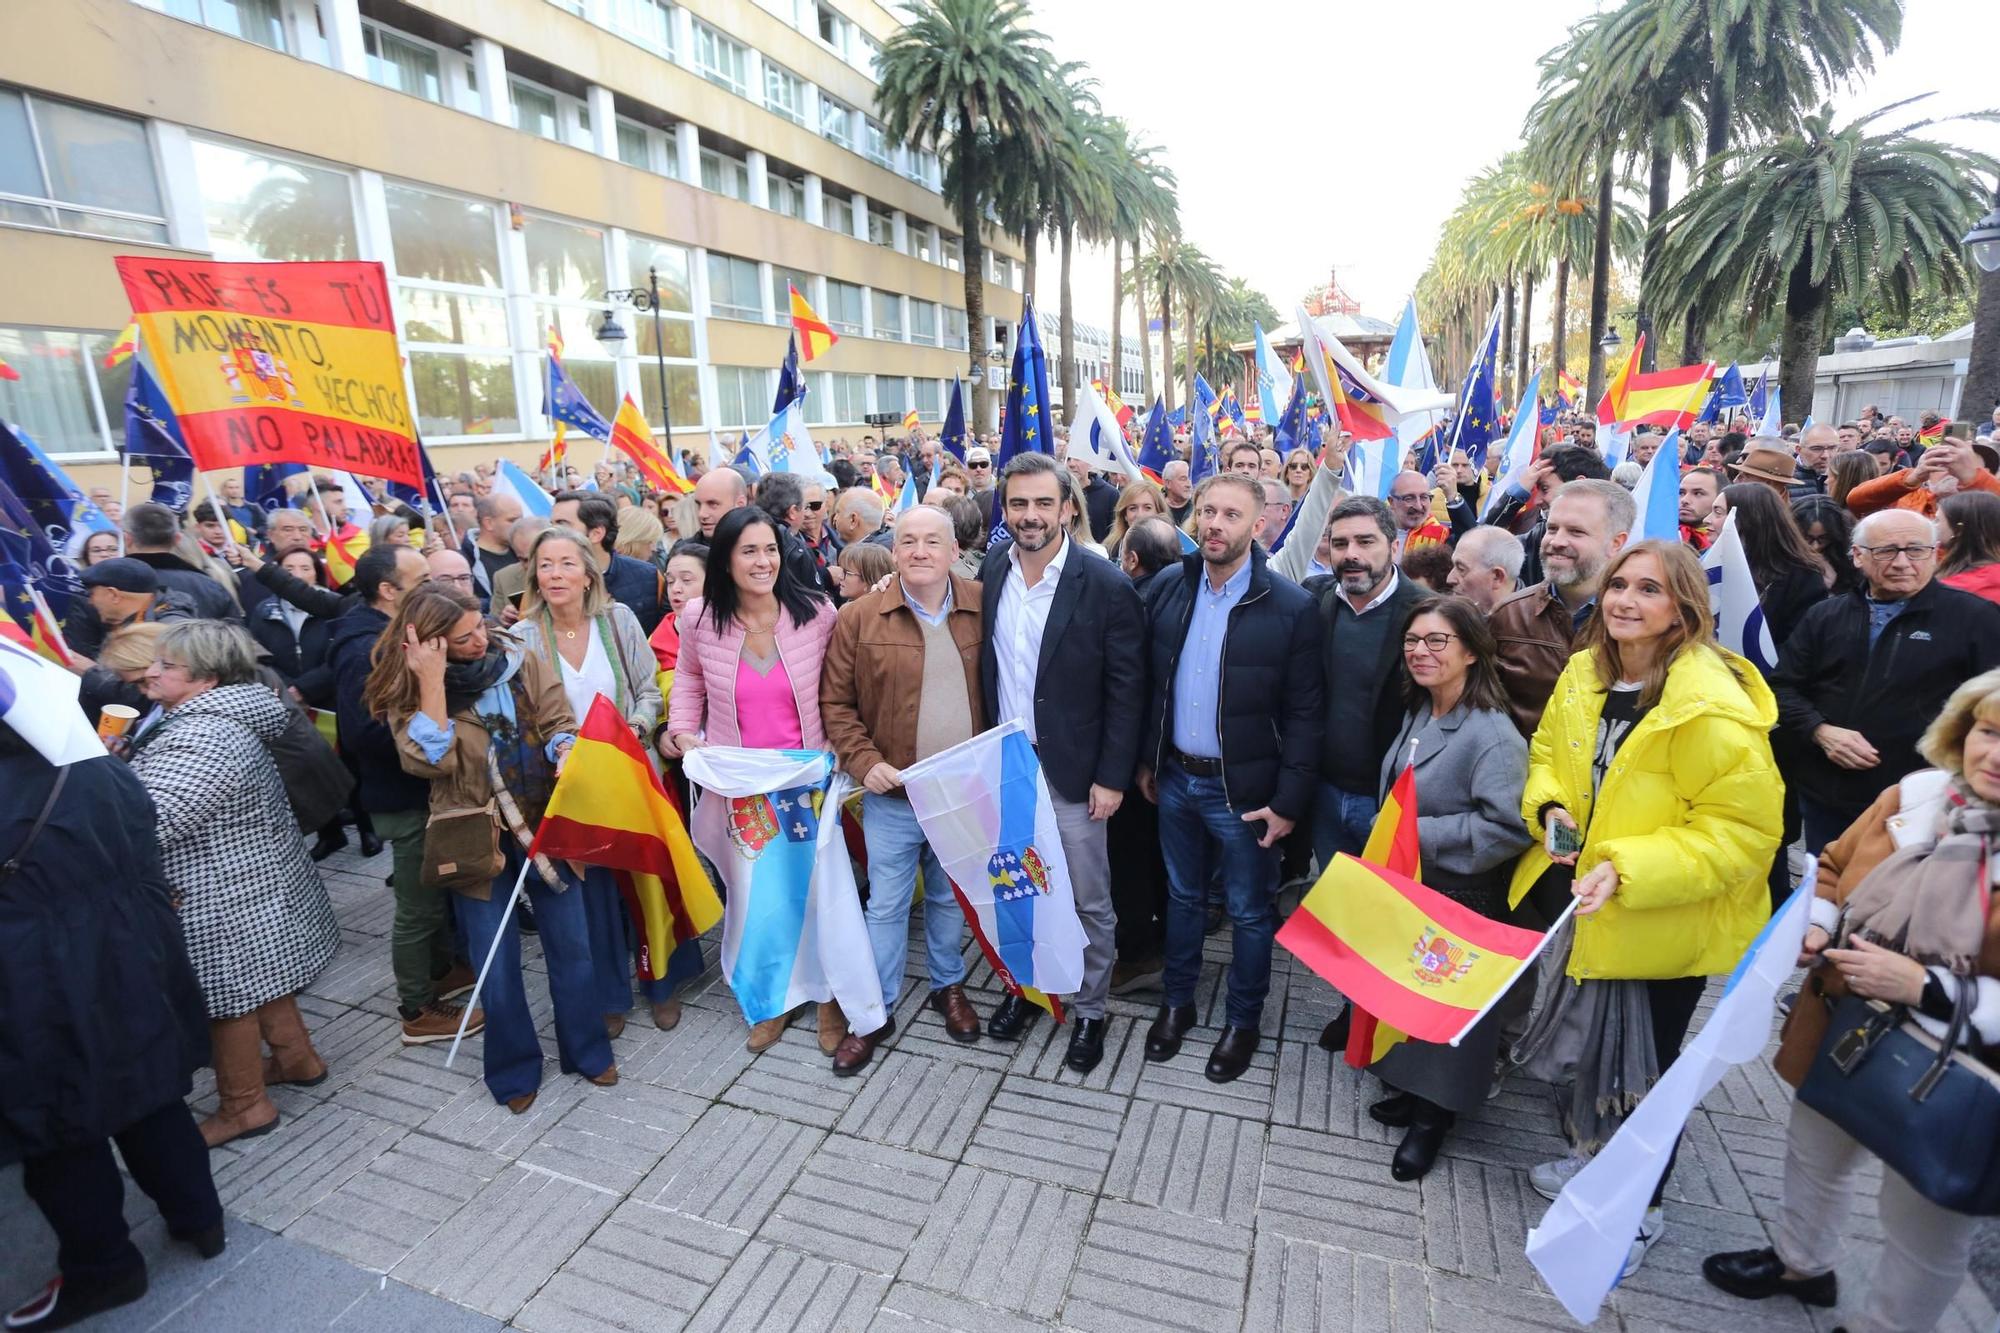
820, 504, 988, 1077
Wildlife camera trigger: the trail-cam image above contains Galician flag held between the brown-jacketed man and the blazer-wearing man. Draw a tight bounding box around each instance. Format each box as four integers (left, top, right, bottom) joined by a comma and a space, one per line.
908, 721, 1084, 1019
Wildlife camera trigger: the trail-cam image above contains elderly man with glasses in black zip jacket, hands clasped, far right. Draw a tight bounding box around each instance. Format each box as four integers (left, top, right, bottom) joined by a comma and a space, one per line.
1770, 508, 2000, 853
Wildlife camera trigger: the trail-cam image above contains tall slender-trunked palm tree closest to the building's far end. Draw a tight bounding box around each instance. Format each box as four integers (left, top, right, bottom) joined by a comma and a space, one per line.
876, 0, 1058, 420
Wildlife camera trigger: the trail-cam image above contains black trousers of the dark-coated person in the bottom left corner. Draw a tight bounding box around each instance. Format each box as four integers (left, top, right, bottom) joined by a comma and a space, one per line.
22, 1101, 222, 1287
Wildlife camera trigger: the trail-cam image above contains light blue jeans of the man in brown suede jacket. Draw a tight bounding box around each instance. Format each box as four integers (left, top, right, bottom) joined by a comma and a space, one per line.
862, 791, 966, 1009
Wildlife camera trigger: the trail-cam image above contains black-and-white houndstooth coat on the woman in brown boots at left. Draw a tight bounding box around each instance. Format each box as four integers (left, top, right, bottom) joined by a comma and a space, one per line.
132, 685, 340, 1019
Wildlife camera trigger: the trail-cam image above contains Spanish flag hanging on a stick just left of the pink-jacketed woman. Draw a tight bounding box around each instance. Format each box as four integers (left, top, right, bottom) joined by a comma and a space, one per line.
528, 695, 722, 964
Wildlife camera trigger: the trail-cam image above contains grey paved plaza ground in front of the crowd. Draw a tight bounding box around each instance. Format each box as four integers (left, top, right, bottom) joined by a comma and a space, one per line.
0, 840, 1996, 1333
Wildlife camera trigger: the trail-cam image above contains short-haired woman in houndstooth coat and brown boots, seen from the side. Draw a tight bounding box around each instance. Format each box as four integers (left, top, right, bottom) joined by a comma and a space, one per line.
130, 620, 340, 1147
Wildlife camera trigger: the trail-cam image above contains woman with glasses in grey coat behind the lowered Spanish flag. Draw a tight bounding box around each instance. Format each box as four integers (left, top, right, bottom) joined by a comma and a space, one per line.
1368, 596, 1534, 1181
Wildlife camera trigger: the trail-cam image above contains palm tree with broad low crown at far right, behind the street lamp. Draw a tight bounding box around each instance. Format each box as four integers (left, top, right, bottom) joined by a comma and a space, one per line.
1656, 98, 2000, 410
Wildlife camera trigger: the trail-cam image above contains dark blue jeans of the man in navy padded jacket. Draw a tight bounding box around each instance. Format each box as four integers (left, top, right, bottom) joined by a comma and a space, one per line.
1158, 763, 1280, 1031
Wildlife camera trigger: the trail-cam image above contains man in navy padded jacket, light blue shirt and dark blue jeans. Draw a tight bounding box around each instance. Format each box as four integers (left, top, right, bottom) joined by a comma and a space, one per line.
1138, 474, 1322, 1083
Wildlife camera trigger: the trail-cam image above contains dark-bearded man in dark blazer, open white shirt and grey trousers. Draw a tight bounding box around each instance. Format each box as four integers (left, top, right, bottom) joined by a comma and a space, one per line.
980, 454, 1146, 1073
